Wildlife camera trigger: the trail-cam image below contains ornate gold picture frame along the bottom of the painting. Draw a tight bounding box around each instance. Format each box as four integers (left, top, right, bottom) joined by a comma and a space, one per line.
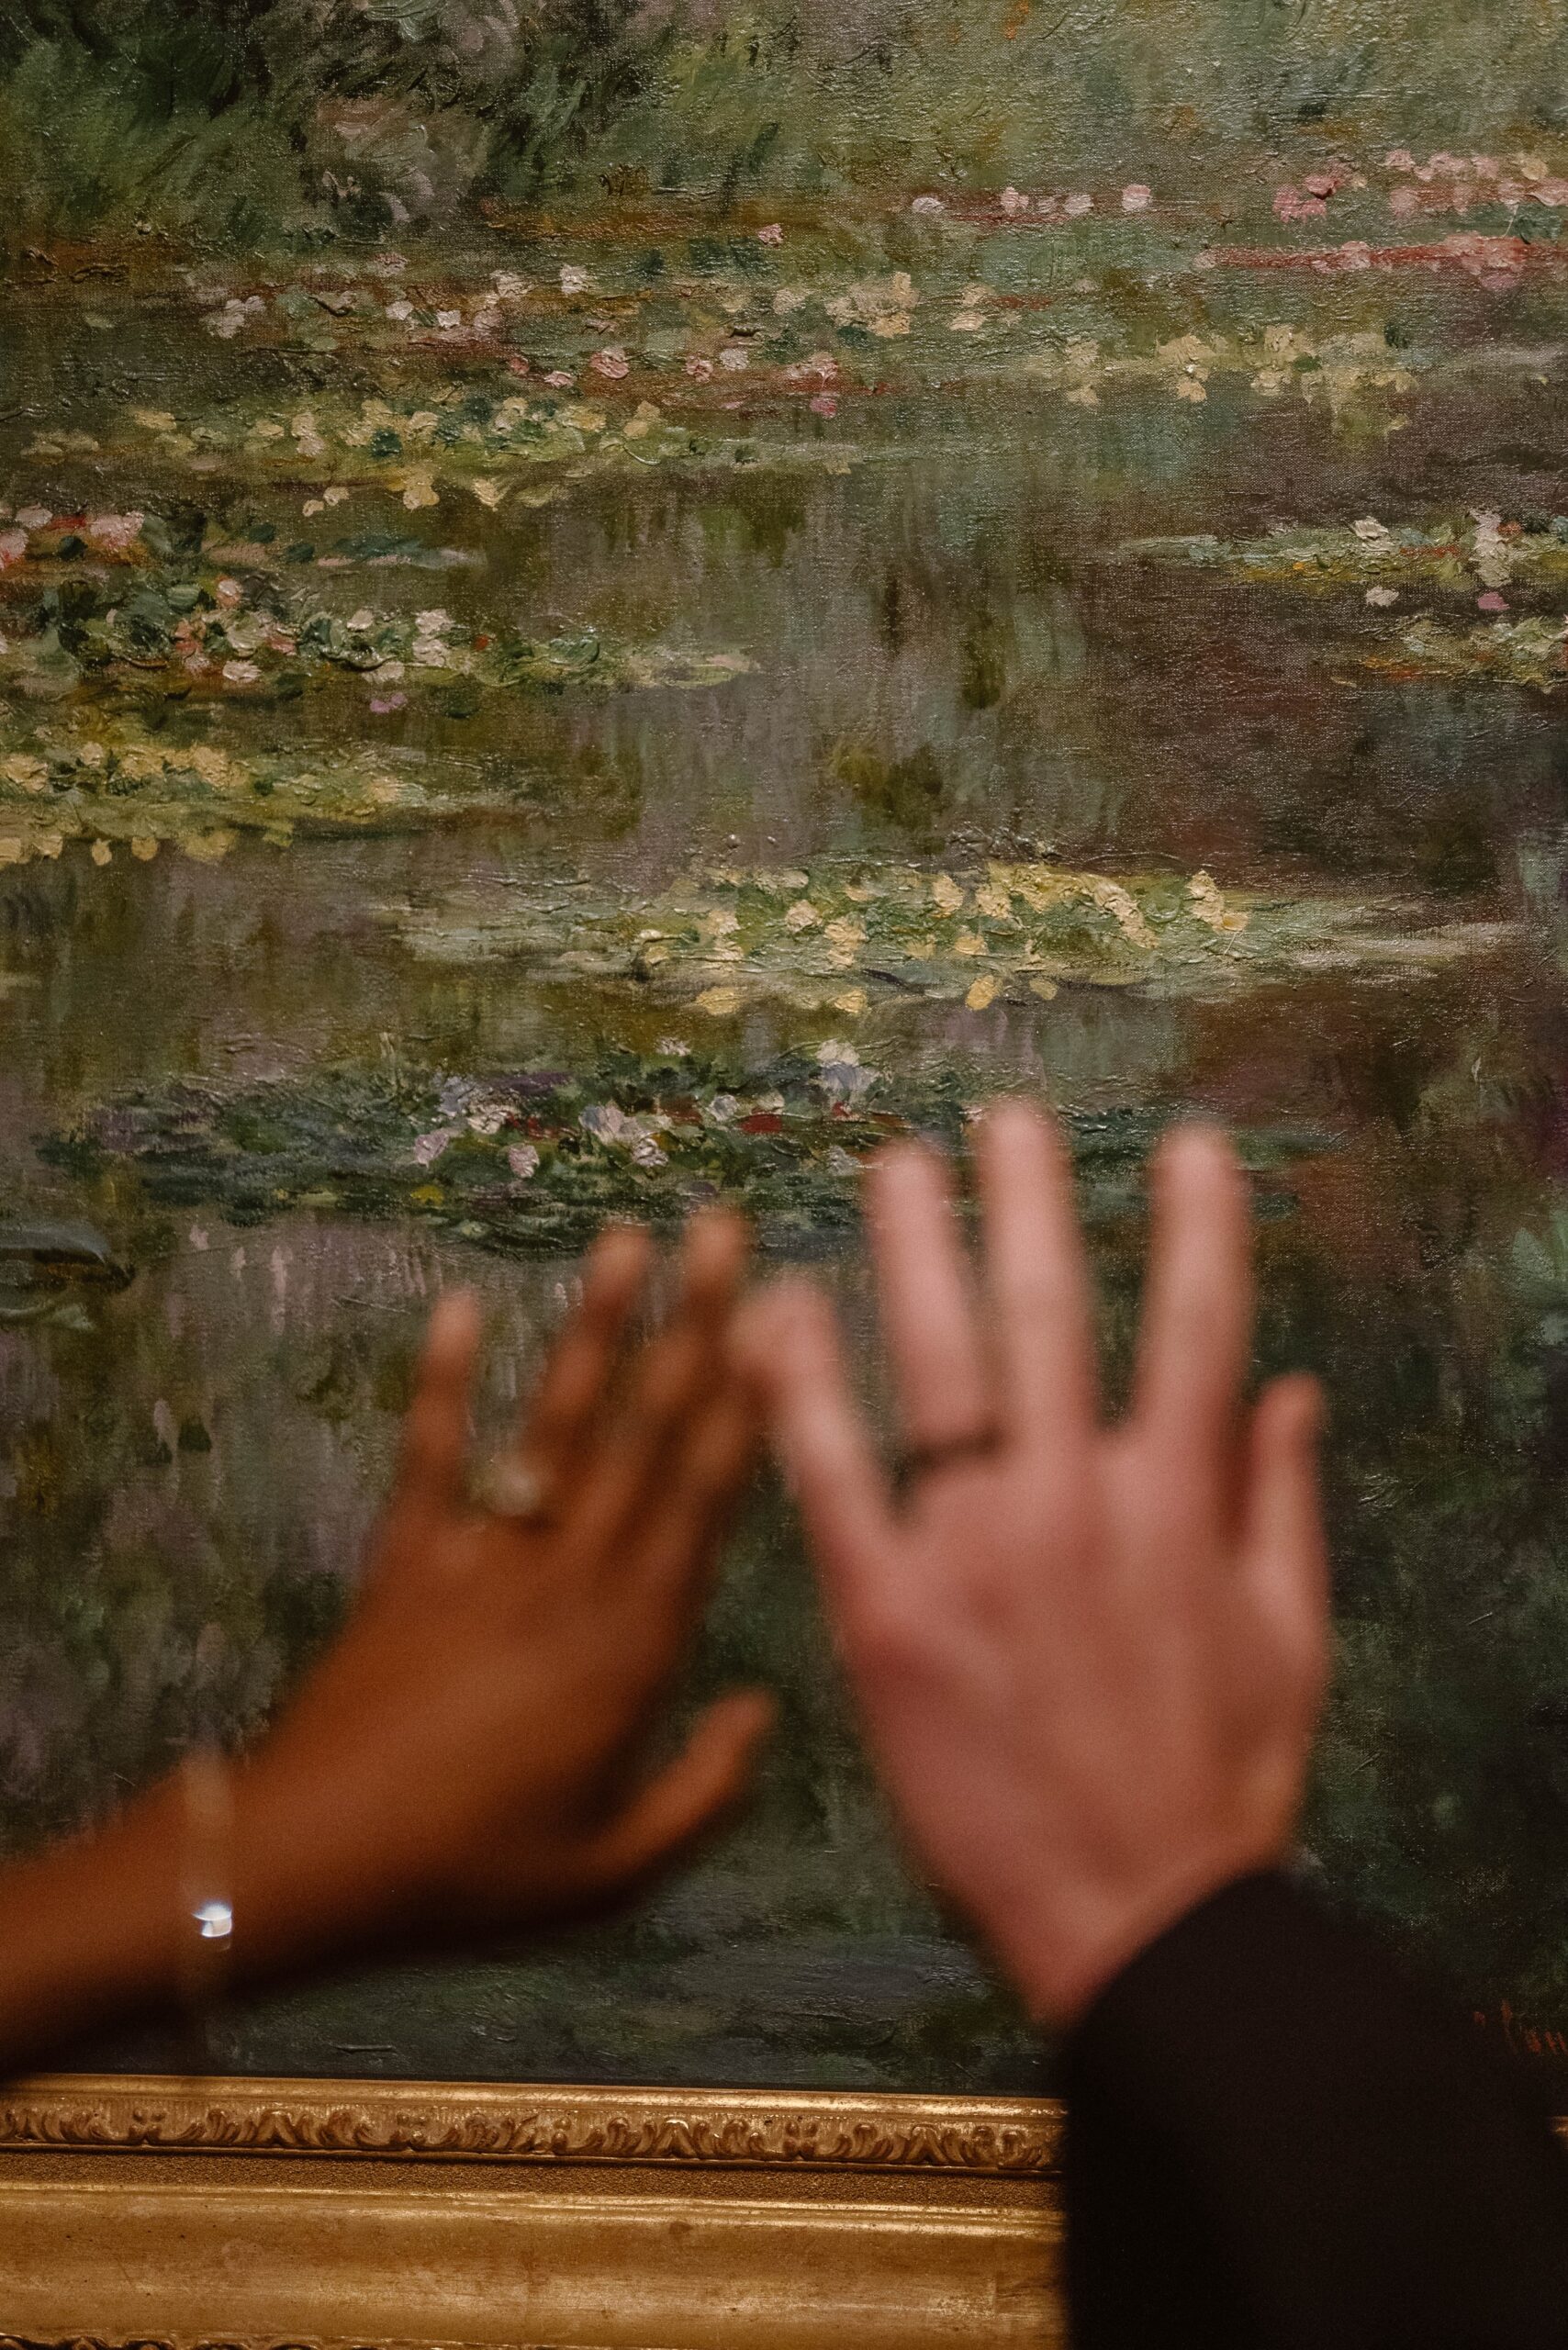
0, 2075, 1062, 2350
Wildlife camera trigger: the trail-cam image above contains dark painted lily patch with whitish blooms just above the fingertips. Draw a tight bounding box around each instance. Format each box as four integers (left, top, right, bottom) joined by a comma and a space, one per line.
42, 1058, 1333, 1252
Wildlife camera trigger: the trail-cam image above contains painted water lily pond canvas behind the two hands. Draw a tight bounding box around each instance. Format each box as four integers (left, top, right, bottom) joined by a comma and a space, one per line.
0, 0, 1568, 2089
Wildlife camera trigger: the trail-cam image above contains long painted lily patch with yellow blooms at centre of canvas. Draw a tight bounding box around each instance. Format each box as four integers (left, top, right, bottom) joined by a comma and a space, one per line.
390, 860, 1495, 1020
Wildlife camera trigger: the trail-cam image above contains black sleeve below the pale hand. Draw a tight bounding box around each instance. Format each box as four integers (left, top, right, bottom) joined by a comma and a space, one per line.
1065, 1875, 1568, 2350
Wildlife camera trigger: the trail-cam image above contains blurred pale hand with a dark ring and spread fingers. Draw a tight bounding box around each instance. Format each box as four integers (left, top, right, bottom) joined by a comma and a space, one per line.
738, 1102, 1326, 2026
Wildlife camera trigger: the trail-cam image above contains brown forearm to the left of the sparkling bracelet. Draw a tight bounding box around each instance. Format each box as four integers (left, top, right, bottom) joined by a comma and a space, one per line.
0, 1779, 184, 2075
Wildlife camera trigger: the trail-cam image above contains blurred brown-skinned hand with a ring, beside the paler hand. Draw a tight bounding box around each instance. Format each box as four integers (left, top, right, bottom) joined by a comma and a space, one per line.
235, 1213, 771, 1972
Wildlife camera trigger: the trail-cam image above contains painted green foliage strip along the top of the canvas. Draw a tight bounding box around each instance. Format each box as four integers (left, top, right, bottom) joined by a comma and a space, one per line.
0, 0, 1568, 249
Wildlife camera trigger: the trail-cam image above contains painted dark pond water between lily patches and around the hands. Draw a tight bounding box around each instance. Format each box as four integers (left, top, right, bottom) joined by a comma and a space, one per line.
0, 266, 1568, 2089
